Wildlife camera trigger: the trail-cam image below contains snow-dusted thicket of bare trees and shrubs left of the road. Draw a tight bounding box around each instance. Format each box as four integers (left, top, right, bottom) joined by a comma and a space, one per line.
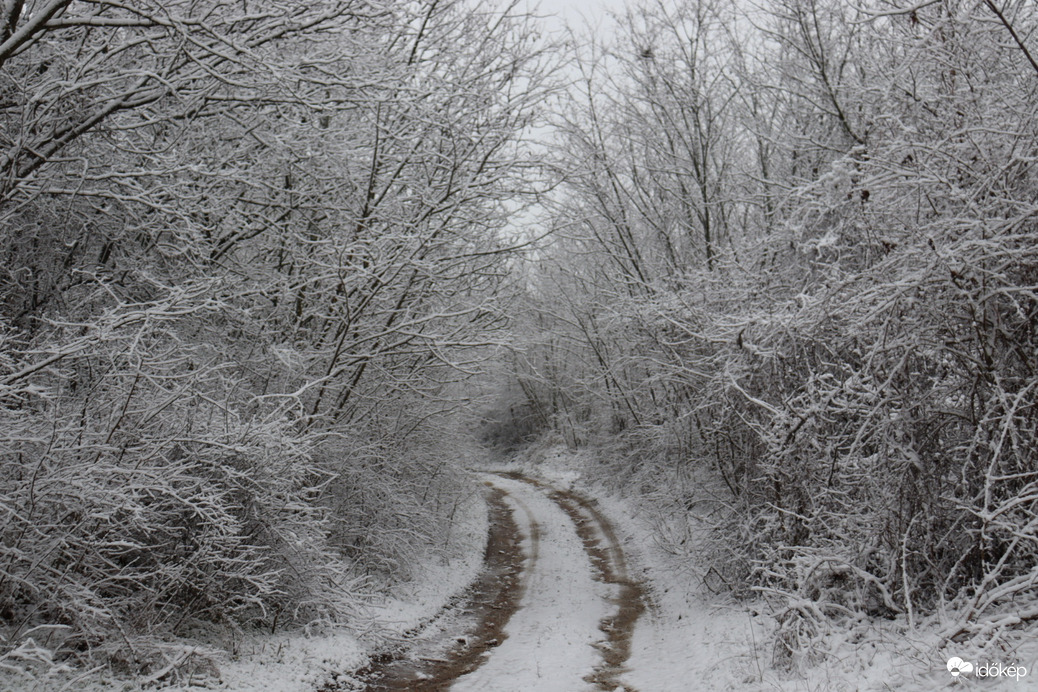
0, 0, 546, 677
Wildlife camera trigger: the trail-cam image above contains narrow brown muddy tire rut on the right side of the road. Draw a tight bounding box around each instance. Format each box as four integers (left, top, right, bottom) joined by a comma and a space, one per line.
500, 472, 645, 692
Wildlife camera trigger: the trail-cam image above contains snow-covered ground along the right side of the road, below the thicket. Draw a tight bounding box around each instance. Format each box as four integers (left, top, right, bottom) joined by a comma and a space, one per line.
512, 446, 1038, 692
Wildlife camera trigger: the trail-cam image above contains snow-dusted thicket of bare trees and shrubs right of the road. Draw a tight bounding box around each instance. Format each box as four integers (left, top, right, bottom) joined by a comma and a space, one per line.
515, 0, 1038, 662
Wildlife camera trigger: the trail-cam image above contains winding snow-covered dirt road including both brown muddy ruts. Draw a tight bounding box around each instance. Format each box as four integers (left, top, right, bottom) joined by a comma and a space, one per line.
367, 474, 644, 692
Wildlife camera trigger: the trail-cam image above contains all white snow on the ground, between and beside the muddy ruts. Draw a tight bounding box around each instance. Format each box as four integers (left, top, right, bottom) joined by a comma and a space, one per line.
10, 446, 1038, 692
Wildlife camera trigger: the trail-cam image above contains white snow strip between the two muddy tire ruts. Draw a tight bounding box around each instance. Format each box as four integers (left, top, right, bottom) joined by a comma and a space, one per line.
450, 476, 616, 692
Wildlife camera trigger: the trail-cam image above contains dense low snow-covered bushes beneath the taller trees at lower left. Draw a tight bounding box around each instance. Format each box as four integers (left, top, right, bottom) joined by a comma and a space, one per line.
0, 292, 367, 672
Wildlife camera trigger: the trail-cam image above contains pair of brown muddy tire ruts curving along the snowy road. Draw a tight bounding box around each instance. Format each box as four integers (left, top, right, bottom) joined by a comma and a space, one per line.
346, 473, 645, 692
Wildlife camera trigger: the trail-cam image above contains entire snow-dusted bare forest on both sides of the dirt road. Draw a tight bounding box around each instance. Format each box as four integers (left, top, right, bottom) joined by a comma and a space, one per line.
0, 0, 1038, 680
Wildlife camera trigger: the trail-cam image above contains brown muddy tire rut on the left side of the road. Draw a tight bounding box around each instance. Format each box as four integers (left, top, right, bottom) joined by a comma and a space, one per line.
332, 483, 527, 692
